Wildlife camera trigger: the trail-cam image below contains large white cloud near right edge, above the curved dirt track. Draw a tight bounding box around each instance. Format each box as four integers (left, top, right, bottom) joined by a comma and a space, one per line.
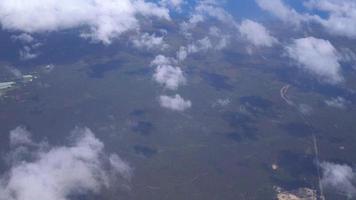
286, 37, 343, 84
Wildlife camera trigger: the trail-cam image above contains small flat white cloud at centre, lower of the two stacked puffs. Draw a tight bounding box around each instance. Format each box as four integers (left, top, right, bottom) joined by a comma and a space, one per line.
159, 94, 192, 111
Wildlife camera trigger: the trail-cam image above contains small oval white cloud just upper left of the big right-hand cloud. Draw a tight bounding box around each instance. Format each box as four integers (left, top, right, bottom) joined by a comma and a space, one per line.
239, 19, 277, 47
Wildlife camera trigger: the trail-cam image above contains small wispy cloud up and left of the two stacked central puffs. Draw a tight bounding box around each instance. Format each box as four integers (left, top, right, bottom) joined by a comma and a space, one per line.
132, 33, 168, 50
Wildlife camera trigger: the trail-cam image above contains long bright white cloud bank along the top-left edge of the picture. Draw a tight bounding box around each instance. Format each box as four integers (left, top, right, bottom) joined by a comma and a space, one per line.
0, 0, 170, 44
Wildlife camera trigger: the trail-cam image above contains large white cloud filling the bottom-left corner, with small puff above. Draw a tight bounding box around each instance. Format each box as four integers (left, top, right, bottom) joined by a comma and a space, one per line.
0, 128, 131, 200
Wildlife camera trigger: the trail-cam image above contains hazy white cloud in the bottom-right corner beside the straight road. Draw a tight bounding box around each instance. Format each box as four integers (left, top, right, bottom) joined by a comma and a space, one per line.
320, 162, 356, 197
